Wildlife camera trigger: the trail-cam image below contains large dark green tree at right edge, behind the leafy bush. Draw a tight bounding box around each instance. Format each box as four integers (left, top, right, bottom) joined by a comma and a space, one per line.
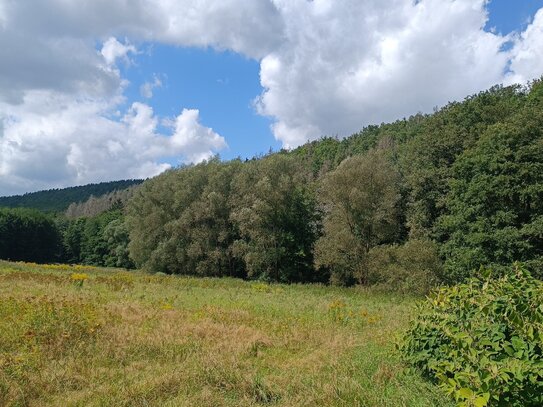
436, 81, 543, 282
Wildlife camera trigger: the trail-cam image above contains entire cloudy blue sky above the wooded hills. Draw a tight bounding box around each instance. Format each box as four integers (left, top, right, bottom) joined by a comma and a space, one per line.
0, 0, 543, 196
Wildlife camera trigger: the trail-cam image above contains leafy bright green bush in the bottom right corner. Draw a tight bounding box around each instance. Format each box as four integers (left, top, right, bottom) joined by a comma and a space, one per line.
401, 265, 543, 406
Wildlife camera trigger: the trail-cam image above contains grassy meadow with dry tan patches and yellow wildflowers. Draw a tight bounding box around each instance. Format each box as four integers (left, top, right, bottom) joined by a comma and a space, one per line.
0, 262, 449, 407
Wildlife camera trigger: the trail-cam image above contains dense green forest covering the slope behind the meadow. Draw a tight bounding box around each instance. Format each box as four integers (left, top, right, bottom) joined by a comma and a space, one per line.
0, 80, 543, 292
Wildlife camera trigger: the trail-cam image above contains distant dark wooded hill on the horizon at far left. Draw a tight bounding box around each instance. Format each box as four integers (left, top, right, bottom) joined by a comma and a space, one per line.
0, 179, 143, 212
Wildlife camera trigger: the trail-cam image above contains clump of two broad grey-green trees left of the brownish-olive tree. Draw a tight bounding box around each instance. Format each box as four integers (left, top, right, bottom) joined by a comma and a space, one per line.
127, 155, 324, 281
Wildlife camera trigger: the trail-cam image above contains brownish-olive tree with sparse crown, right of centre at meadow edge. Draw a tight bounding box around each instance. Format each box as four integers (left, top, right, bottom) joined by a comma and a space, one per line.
316, 150, 400, 284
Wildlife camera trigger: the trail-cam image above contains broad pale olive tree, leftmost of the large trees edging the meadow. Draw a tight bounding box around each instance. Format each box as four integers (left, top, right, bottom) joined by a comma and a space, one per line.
127, 159, 244, 276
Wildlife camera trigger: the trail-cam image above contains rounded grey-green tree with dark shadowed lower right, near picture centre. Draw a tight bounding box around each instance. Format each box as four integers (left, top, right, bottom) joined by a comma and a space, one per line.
231, 155, 320, 282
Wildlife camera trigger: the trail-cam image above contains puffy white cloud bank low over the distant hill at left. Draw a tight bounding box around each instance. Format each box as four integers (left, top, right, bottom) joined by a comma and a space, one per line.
0, 91, 226, 195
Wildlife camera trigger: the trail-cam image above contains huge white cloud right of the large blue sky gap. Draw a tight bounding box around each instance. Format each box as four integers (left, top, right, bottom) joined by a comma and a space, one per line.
257, 0, 507, 147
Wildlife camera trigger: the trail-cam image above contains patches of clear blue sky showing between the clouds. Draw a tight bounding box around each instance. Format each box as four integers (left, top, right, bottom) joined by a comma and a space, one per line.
123, 0, 543, 163
